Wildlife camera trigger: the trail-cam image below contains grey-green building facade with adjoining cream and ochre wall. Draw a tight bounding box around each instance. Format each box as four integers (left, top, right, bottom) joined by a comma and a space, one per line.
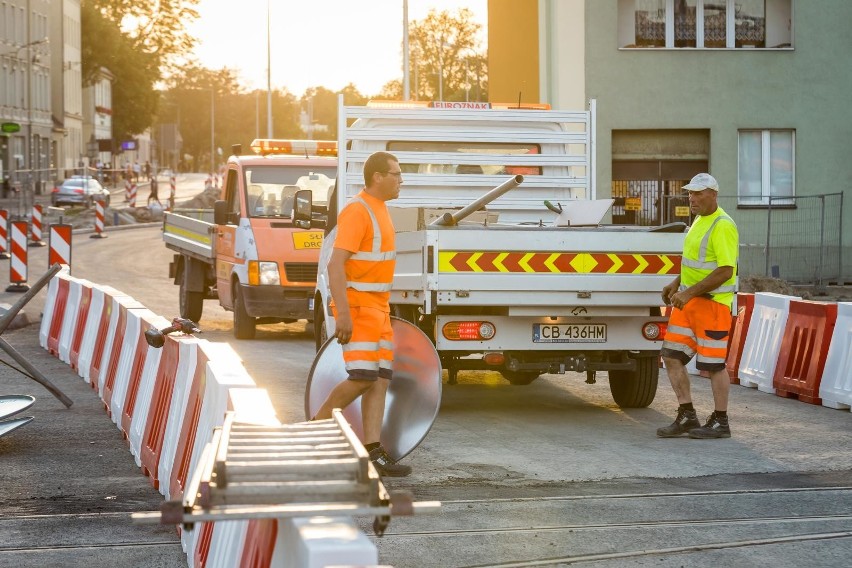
489, 0, 852, 281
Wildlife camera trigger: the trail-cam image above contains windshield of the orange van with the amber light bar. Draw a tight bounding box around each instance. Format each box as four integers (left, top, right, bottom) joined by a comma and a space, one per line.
245, 165, 337, 218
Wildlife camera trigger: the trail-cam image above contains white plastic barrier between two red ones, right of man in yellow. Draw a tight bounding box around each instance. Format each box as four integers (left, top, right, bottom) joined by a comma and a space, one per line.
739, 292, 801, 393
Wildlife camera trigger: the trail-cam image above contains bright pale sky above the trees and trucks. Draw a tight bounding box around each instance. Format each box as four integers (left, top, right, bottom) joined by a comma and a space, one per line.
188, 0, 488, 96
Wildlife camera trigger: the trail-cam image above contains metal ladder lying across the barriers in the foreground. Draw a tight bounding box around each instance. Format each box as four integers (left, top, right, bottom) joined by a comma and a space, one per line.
133, 409, 441, 536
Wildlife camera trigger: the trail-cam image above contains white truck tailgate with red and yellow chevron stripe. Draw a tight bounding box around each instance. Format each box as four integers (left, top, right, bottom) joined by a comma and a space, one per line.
394, 225, 684, 315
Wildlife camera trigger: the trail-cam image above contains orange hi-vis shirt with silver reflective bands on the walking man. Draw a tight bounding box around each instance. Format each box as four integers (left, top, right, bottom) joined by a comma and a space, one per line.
334, 190, 396, 312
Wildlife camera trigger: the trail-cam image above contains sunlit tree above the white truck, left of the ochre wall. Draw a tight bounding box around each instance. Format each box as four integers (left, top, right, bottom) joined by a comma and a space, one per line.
406, 8, 488, 101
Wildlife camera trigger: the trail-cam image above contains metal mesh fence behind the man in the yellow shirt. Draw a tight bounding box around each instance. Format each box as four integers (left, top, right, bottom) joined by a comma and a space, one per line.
664, 193, 849, 287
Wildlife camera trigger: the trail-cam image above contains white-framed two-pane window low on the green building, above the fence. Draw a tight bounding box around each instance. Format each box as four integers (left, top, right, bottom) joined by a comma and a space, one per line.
737, 130, 796, 206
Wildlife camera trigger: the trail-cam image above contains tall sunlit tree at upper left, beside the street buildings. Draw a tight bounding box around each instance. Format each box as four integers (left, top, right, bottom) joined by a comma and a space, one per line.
80, 0, 199, 140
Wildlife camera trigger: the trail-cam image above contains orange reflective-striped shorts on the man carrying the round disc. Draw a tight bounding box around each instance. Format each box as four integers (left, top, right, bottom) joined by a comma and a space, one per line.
334, 306, 393, 381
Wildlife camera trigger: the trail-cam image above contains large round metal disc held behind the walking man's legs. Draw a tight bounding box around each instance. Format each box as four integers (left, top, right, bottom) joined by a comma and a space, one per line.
305, 317, 441, 460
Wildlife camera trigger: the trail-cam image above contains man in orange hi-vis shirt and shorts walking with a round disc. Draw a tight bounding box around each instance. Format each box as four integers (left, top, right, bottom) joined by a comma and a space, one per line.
313, 152, 411, 477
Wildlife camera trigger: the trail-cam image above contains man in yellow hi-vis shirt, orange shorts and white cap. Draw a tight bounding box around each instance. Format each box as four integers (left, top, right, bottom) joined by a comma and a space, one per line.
657, 173, 739, 439
